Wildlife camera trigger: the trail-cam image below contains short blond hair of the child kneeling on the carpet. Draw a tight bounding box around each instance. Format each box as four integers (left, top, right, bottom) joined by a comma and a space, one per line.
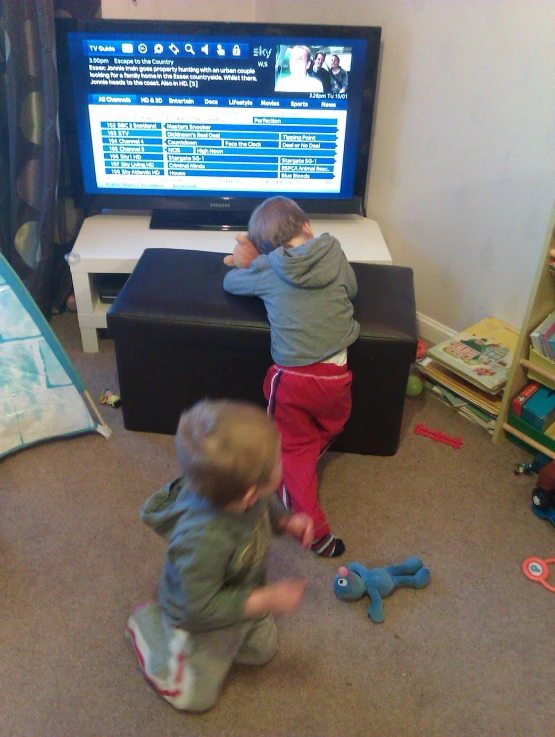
176, 399, 280, 507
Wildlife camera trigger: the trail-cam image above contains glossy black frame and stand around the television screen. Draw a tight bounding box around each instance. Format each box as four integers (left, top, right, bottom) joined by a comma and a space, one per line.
56, 18, 382, 229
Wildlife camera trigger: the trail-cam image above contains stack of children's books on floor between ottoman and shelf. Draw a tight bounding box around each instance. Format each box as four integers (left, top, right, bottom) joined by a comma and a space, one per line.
417, 317, 518, 433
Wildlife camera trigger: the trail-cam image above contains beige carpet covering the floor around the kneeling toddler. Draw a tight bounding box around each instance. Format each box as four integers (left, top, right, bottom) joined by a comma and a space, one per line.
0, 313, 555, 737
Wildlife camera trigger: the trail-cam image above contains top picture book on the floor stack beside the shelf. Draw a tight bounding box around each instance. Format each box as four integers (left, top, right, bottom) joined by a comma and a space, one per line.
426, 317, 519, 394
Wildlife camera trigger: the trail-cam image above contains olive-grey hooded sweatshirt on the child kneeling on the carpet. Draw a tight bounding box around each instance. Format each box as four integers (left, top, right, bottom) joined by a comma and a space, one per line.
141, 478, 289, 632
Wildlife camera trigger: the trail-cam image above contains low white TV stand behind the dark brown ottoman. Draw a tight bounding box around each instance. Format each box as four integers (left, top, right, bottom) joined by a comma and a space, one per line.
67, 213, 391, 353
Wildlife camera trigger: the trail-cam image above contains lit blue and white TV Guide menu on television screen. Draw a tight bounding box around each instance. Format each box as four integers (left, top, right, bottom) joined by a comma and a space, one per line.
72, 33, 364, 194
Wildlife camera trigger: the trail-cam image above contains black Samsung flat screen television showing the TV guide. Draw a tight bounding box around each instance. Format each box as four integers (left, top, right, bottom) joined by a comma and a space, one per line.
56, 19, 381, 229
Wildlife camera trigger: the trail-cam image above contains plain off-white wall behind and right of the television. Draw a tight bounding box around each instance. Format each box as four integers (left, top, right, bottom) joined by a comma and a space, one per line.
102, 0, 555, 340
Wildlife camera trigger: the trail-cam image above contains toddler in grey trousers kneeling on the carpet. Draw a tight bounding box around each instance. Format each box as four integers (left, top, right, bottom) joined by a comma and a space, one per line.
127, 400, 313, 711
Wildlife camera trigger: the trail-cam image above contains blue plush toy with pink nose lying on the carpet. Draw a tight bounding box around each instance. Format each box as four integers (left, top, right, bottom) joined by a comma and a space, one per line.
333, 558, 430, 622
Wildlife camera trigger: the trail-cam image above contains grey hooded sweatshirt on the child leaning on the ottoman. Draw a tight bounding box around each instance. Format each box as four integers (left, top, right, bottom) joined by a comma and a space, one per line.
224, 233, 360, 366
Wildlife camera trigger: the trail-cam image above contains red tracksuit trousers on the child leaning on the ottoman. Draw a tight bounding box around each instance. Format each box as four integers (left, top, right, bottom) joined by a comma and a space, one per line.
264, 363, 352, 540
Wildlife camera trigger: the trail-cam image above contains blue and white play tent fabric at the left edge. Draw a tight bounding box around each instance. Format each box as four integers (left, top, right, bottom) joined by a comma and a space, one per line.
0, 255, 110, 458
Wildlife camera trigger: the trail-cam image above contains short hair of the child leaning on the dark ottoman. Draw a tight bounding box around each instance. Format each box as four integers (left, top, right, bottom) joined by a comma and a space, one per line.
247, 195, 309, 254
